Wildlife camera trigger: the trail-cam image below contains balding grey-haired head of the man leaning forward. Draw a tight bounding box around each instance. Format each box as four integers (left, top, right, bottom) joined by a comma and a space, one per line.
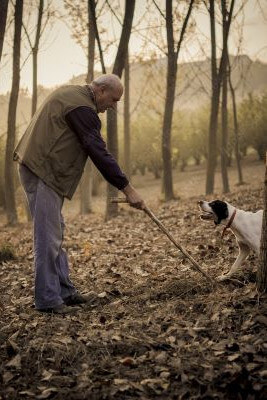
90, 74, 123, 112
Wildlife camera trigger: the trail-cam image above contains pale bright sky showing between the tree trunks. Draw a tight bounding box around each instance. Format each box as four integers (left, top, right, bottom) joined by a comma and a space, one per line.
0, 0, 267, 93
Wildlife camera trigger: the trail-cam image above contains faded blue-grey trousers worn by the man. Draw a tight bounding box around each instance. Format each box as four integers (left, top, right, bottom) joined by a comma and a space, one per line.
19, 164, 76, 309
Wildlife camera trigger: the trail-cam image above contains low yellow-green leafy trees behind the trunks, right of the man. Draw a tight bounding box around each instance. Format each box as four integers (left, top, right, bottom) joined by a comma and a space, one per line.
131, 94, 267, 178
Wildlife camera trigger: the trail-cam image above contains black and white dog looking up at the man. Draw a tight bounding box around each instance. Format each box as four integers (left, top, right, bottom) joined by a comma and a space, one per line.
198, 200, 263, 281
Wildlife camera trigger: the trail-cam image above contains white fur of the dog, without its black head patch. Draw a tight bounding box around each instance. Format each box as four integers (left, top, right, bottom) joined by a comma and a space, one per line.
199, 201, 263, 281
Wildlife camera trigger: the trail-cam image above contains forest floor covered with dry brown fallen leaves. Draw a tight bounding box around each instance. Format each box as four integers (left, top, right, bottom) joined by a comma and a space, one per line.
0, 159, 267, 400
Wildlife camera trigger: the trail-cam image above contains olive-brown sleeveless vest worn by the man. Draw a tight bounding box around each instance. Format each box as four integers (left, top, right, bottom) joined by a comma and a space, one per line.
14, 85, 96, 199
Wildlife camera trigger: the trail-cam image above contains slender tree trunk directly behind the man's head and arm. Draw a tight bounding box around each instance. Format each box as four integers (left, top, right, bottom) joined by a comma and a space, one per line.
80, 0, 96, 214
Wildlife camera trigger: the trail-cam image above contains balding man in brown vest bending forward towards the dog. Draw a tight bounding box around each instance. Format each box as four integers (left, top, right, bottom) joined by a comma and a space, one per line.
14, 74, 145, 314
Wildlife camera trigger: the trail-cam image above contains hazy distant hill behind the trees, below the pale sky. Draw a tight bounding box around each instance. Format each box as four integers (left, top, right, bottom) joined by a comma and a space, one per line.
0, 55, 267, 135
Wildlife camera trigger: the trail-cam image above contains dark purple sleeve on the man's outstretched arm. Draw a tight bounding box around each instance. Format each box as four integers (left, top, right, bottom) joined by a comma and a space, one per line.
66, 106, 129, 190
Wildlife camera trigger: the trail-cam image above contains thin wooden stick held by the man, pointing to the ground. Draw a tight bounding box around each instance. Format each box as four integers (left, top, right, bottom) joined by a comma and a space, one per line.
111, 198, 215, 283
